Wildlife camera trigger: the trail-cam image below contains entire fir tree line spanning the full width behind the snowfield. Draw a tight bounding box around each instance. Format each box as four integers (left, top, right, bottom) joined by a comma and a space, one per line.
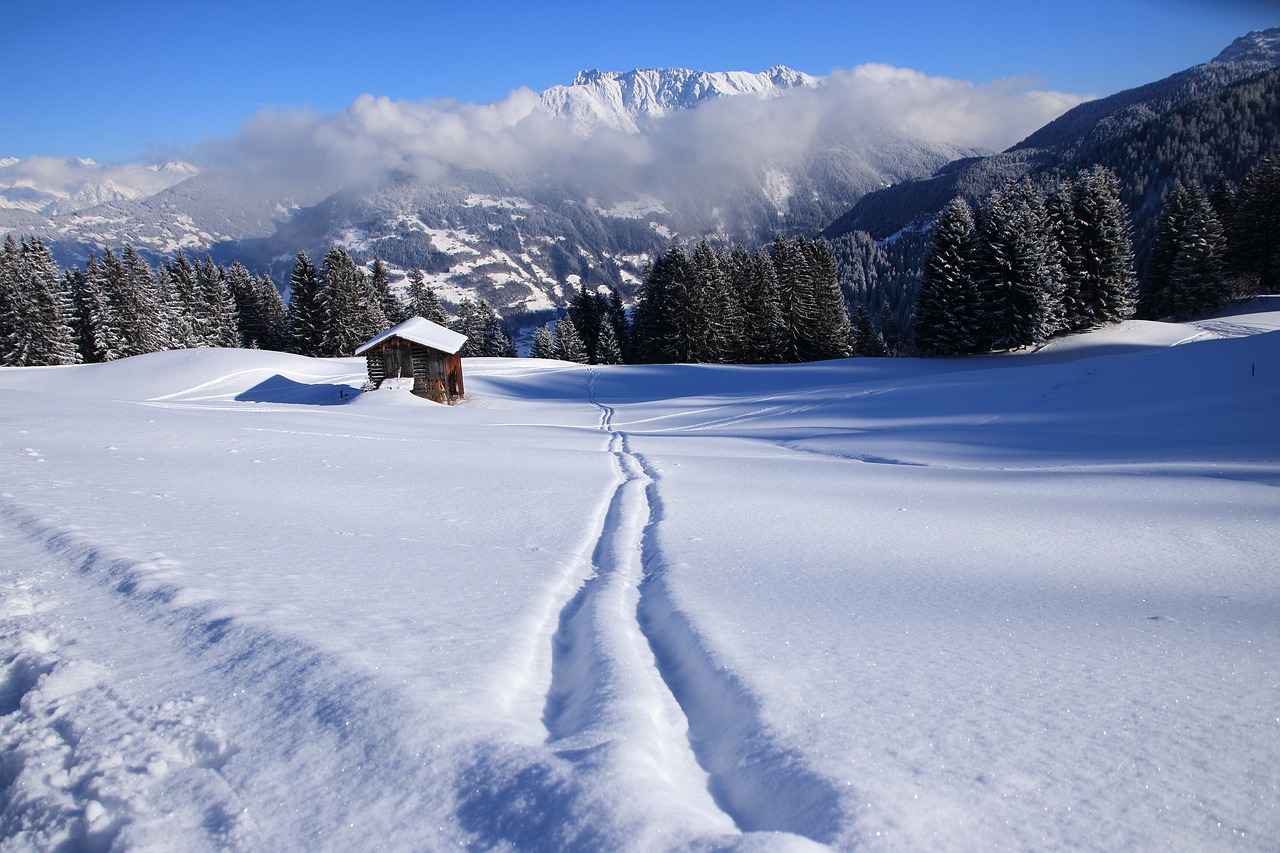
0, 156, 1280, 365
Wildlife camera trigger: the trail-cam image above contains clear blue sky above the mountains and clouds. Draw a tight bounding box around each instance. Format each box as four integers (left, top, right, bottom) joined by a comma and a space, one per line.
0, 0, 1280, 163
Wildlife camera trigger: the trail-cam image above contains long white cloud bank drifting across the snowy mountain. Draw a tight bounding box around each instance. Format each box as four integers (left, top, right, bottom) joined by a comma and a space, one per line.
194, 64, 1085, 197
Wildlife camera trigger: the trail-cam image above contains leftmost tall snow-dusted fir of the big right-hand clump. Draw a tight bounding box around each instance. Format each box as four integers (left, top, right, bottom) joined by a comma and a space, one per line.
911, 196, 979, 356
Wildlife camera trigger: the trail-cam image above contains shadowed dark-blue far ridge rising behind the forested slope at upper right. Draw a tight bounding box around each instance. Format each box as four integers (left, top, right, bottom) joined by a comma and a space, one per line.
823, 28, 1280, 240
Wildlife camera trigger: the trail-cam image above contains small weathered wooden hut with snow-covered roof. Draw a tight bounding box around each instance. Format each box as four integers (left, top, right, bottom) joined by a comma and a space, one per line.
356, 316, 467, 403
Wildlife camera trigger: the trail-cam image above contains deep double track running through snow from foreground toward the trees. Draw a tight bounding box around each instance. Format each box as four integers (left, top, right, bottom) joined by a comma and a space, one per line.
543, 370, 842, 843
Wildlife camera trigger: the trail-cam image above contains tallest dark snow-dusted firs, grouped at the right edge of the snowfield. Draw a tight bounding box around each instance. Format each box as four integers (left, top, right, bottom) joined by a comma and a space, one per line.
913, 156, 1280, 355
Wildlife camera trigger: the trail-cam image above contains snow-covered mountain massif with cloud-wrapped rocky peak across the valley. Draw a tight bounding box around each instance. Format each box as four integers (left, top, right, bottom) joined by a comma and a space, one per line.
0, 67, 975, 315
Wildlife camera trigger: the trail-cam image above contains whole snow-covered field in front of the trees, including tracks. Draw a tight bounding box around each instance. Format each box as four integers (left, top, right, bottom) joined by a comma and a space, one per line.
0, 297, 1280, 850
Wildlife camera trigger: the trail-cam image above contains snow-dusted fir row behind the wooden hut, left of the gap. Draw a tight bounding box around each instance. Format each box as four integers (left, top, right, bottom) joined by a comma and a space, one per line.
0, 234, 515, 366
